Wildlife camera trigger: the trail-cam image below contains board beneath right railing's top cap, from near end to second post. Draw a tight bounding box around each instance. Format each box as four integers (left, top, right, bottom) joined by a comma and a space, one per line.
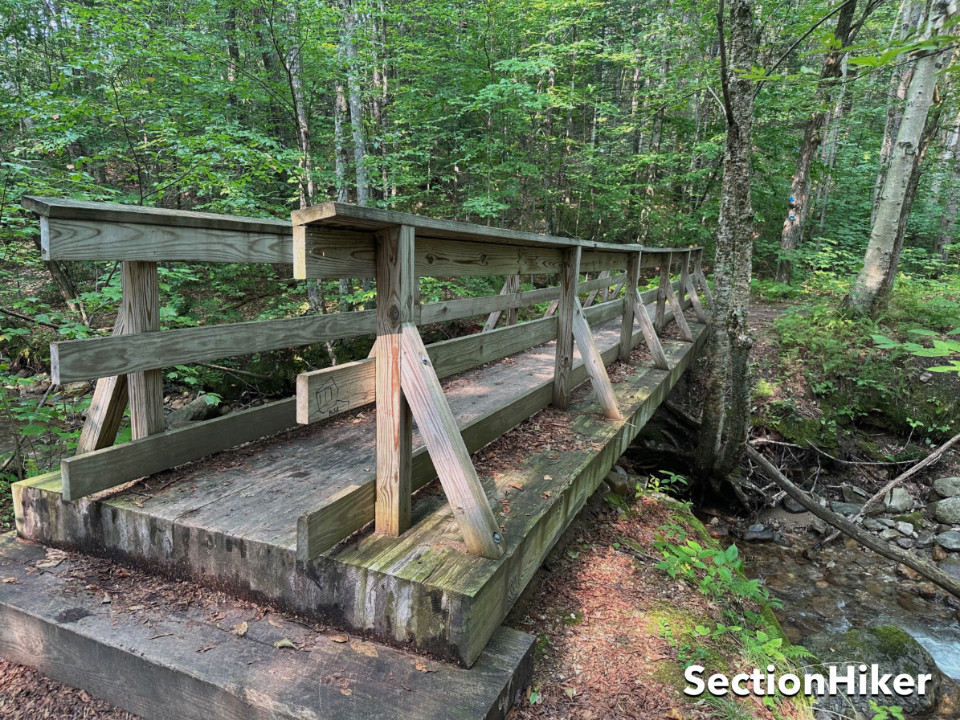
293, 231, 560, 279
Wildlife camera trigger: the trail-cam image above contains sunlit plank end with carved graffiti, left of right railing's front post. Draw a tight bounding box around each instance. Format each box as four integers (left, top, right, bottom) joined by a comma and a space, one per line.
297, 358, 377, 425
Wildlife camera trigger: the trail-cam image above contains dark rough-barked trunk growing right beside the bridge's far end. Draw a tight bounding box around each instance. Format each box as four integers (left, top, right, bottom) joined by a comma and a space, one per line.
696, 0, 758, 488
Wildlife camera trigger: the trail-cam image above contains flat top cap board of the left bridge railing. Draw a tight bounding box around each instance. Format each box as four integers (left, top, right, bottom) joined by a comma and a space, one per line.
20, 195, 293, 235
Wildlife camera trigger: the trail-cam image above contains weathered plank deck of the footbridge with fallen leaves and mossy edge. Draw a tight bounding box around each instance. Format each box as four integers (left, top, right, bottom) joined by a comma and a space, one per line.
15, 306, 705, 665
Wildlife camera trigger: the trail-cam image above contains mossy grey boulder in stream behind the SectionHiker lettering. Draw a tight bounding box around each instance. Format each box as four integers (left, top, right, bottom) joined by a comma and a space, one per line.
803, 625, 945, 718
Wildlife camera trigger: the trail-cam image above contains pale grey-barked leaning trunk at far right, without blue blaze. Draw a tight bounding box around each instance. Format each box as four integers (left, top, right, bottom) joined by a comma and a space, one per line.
843, 0, 952, 314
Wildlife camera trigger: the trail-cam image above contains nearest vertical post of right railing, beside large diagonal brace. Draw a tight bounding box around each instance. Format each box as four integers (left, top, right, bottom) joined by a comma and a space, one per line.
375, 225, 417, 536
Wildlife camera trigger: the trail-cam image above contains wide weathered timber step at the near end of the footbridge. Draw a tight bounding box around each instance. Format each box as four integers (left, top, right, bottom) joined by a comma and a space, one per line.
0, 533, 534, 720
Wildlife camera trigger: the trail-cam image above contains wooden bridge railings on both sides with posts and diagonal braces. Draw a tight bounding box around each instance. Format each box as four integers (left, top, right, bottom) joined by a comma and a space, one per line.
23, 198, 709, 560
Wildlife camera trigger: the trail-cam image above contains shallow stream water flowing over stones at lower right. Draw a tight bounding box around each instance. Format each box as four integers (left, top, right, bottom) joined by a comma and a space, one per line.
738, 524, 960, 681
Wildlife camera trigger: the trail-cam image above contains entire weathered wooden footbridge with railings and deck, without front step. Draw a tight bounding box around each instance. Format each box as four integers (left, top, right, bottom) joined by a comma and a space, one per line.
0, 198, 709, 716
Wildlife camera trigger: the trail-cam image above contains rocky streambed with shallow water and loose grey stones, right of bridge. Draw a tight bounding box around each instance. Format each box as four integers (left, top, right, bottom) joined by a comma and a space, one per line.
708, 477, 960, 717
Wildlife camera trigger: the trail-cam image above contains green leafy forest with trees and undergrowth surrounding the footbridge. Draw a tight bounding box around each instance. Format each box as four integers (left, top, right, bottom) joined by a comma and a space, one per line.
0, 0, 960, 718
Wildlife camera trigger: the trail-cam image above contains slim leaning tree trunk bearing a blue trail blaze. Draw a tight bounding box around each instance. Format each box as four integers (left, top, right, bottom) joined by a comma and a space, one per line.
776, 0, 857, 284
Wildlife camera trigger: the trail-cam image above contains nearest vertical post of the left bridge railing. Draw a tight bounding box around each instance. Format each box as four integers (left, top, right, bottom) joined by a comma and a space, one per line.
120, 261, 167, 440
